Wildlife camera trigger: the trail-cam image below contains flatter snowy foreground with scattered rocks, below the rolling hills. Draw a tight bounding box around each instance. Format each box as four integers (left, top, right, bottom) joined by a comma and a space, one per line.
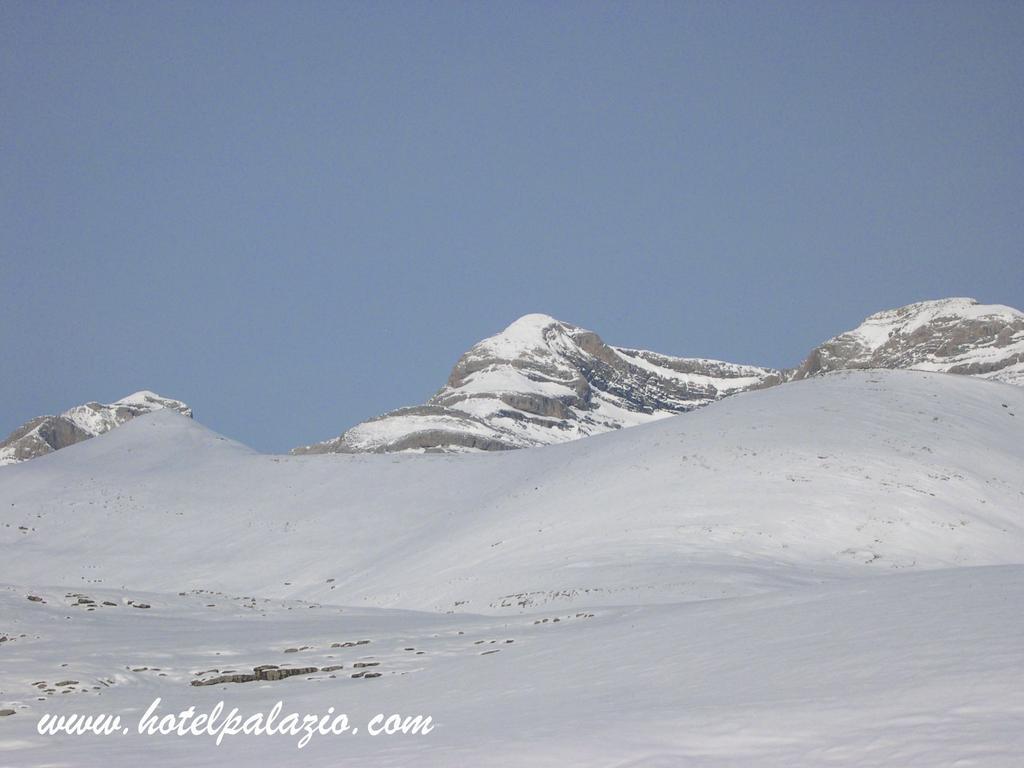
0, 566, 1024, 768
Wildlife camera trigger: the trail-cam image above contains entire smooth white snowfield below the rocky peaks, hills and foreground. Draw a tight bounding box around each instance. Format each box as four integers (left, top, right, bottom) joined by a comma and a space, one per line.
0, 371, 1024, 768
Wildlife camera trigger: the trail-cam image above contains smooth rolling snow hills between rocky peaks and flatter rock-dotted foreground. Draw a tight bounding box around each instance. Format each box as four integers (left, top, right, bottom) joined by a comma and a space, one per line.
0, 371, 1024, 612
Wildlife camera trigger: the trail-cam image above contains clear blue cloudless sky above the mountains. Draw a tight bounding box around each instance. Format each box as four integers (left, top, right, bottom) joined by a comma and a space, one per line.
0, 0, 1024, 451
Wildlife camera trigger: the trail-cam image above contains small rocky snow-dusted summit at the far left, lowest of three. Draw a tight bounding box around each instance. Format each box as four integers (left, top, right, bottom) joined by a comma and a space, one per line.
0, 391, 193, 465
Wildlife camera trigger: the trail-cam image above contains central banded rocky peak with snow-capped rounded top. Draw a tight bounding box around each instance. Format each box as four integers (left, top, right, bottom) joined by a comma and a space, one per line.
293, 314, 782, 454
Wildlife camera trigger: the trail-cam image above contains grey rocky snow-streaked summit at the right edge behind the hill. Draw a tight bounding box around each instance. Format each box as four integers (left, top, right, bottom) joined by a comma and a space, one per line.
796, 299, 1024, 385
